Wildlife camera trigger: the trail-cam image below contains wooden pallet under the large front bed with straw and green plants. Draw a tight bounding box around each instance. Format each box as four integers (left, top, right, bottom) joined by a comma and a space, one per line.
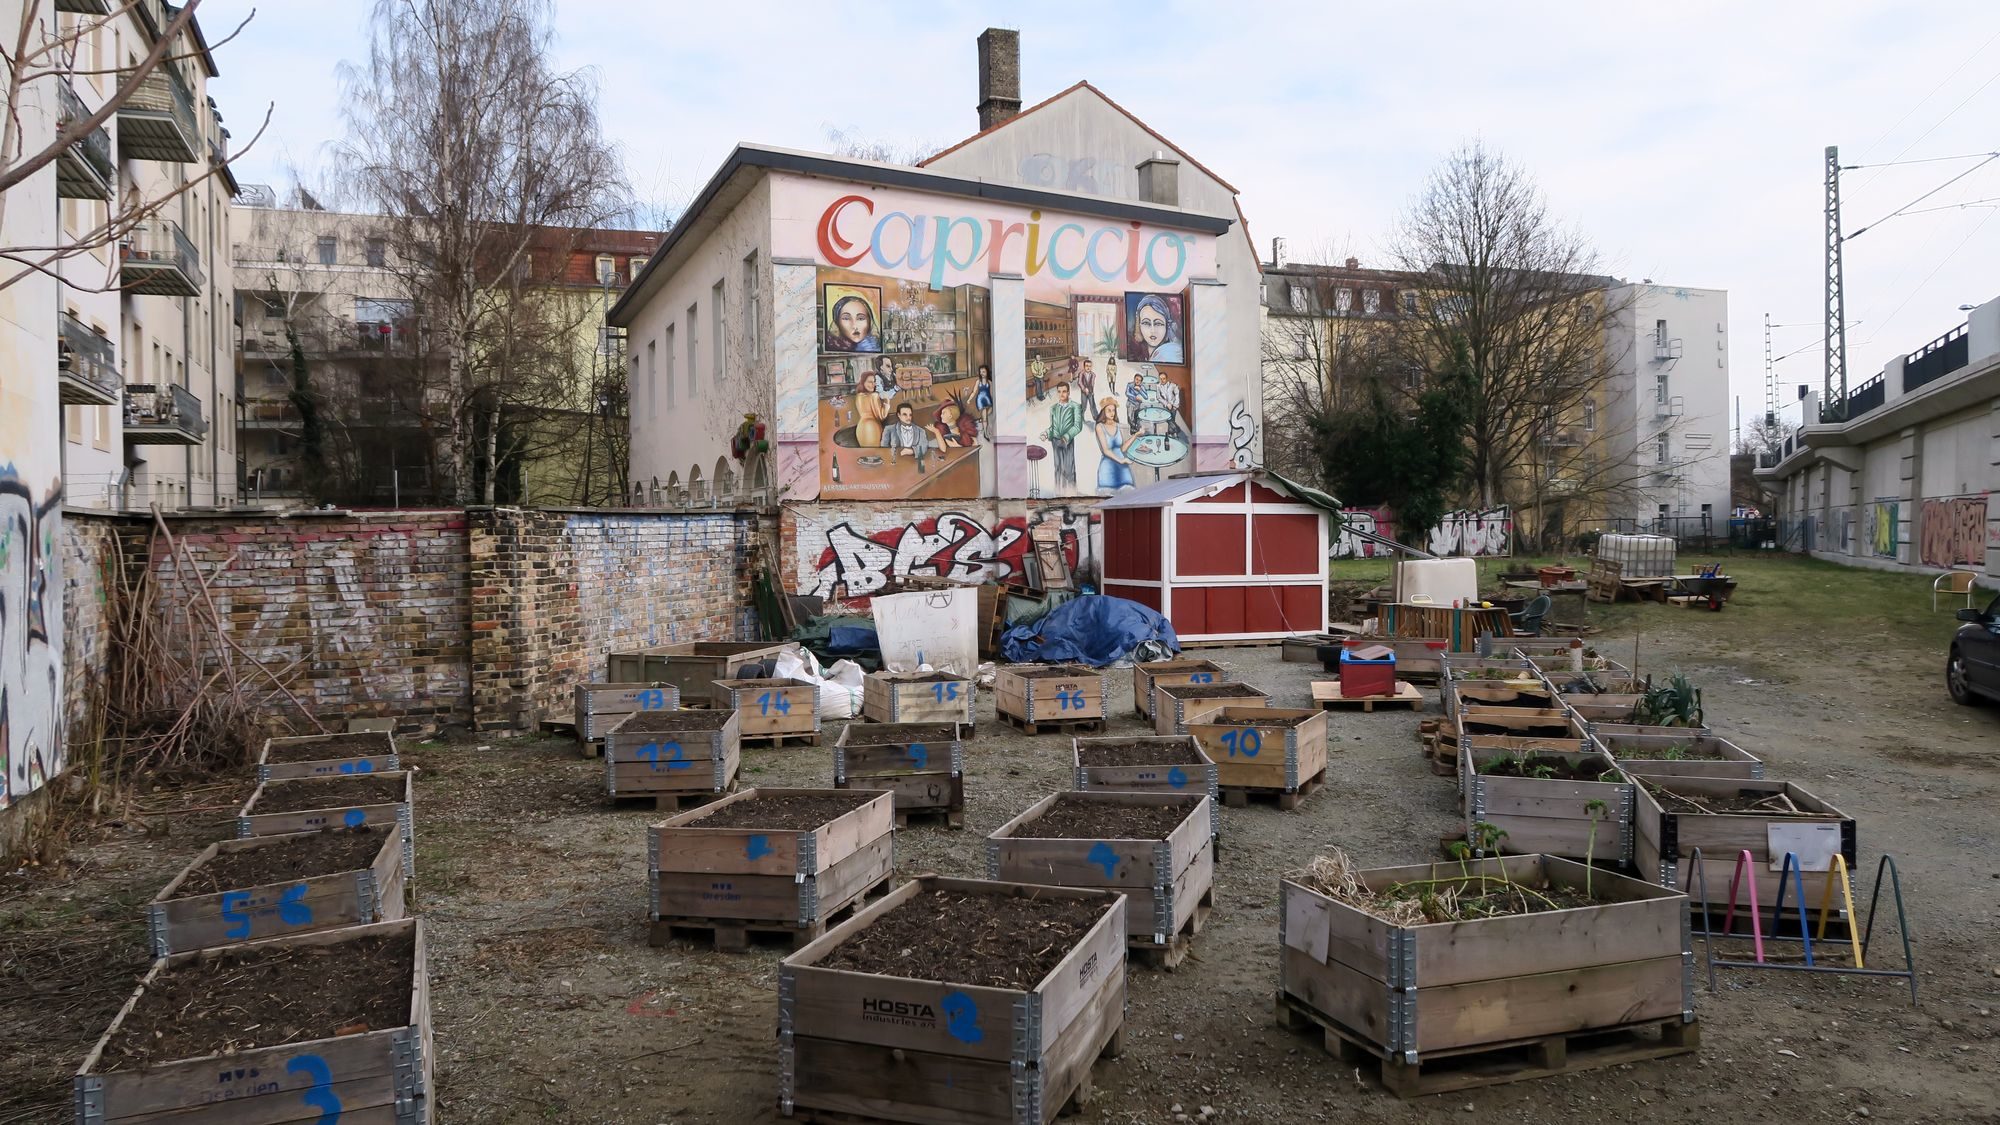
1278, 993, 1702, 1097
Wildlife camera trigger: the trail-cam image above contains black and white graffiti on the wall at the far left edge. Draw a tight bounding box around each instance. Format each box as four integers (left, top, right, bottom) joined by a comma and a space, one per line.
0, 464, 62, 809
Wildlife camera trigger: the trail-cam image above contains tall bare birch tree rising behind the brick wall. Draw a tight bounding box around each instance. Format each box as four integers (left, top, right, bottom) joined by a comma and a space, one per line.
338, 0, 624, 502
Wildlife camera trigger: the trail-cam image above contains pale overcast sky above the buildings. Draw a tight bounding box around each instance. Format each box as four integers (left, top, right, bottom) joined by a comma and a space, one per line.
200, 0, 2000, 434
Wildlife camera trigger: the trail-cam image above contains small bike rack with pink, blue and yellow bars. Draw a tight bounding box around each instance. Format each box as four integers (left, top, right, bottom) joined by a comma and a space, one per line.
1688, 849, 1916, 1007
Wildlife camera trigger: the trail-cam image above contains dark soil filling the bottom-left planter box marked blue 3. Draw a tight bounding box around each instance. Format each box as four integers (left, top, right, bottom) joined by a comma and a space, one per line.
98, 933, 416, 1071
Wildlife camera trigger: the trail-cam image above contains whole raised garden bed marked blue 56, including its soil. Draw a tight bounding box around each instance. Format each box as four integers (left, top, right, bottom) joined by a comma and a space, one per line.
146, 825, 404, 957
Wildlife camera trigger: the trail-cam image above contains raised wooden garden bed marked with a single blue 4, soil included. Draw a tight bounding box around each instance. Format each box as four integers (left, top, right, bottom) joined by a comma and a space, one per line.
986, 791, 1216, 969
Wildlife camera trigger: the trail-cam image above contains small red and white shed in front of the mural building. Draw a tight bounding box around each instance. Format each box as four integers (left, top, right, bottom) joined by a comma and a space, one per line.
1098, 470, 1338, 645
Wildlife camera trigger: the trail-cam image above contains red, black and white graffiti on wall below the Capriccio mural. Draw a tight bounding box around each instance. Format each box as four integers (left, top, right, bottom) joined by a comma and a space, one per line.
798, 508, 1090, 601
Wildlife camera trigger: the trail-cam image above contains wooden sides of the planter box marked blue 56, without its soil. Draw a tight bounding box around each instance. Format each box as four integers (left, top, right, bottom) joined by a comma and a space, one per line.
146, 825, 404, 957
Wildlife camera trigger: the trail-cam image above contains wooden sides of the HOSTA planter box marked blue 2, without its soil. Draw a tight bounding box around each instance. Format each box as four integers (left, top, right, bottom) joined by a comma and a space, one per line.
778, 875, 1126, 1125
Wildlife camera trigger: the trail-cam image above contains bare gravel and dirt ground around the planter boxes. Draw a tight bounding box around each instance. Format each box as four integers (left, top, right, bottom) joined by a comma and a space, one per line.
0, 556, 2000, 1125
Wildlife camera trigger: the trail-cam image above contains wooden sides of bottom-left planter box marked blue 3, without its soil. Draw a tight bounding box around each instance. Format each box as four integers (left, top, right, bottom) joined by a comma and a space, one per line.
72, 919, 436, 1125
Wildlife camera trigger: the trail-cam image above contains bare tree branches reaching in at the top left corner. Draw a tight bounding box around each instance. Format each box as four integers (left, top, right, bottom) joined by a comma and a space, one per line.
0, 0, 270, 292
